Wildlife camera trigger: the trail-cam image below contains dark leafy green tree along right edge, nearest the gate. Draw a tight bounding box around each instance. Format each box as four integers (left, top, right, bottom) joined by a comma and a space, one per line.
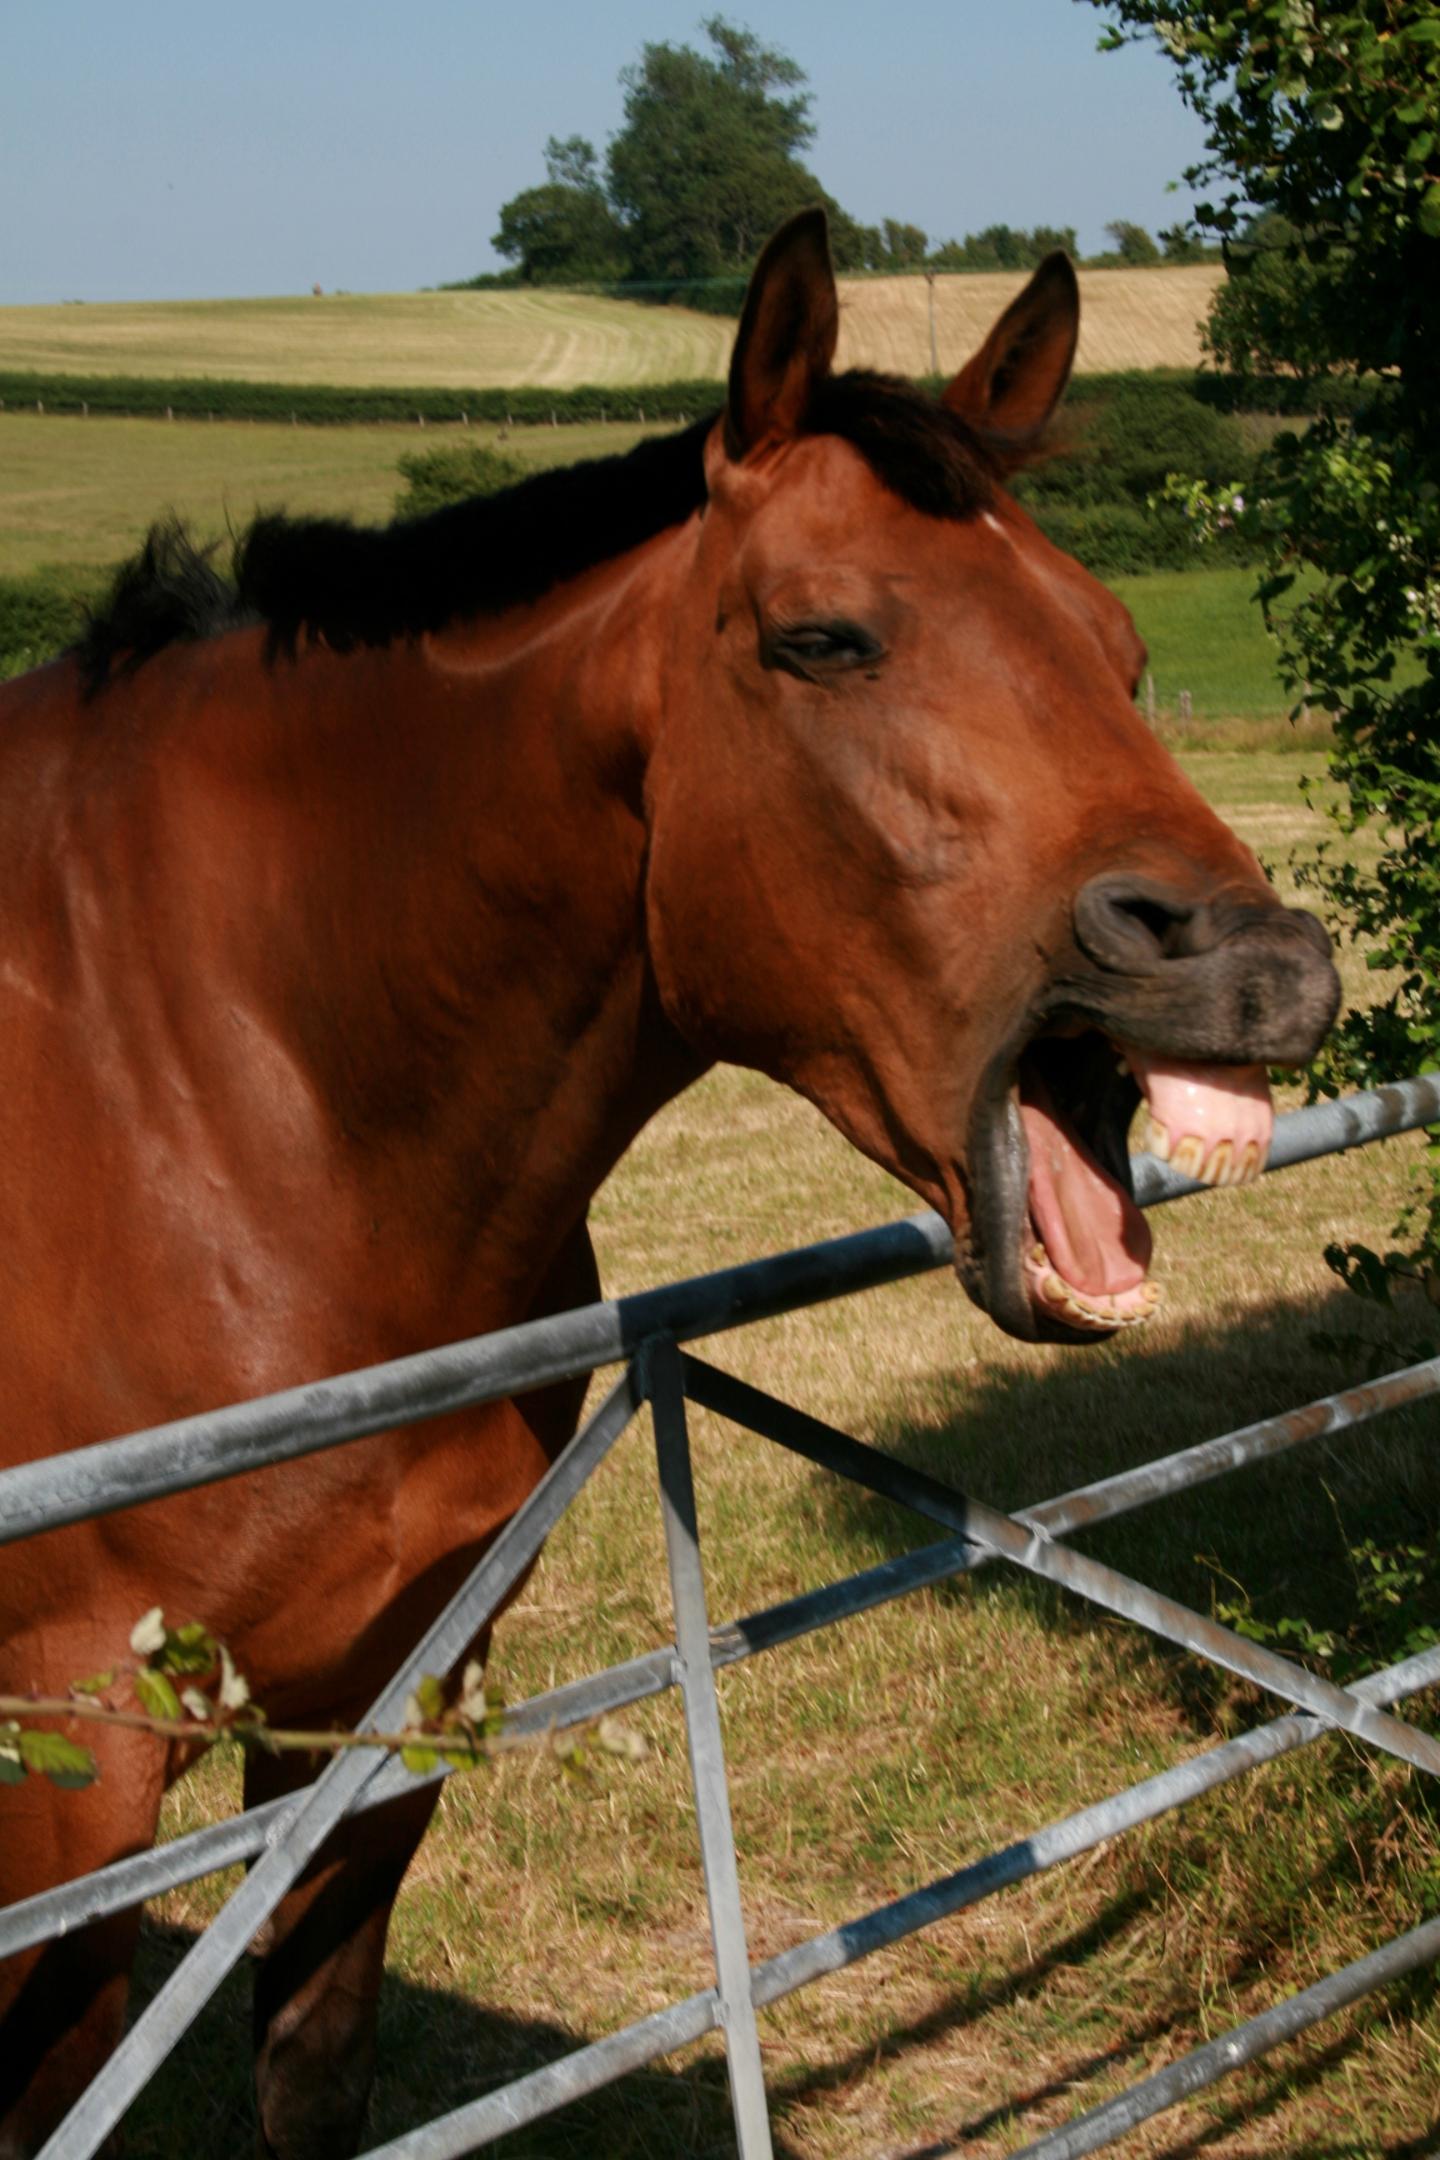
1097, 0, 1440, 1294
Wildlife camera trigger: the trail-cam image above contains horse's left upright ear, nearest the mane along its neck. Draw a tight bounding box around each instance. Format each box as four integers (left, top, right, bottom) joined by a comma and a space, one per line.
725, 210, 840, 458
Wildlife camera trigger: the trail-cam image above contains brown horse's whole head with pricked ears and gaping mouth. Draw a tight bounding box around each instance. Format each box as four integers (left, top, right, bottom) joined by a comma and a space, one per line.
648, 212, 1339, 1339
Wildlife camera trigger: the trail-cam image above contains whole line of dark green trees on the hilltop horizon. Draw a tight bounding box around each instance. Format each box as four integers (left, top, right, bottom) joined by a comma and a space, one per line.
464, 15, 1211, 309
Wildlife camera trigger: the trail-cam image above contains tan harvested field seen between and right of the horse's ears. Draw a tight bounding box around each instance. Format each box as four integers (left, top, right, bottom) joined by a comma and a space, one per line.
833, 264, 1224, 376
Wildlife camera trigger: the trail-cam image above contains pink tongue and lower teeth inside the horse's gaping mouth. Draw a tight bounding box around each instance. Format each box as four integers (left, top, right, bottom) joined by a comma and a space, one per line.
1019, 1074, 1153, 1296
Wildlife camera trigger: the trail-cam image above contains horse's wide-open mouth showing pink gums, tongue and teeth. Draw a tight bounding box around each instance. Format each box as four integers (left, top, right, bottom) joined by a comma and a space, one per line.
976, 1028, 1274, 1339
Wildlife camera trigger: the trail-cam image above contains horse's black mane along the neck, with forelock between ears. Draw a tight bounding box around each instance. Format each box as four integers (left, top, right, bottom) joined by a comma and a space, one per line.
78, 369, 997, 689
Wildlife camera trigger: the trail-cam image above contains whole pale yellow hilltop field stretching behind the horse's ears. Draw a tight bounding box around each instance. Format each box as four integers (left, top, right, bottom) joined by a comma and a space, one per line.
0, 264, 1222, 389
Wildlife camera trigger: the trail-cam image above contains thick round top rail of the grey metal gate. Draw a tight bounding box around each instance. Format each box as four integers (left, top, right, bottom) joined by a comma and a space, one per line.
0, 1074, 1440, 1544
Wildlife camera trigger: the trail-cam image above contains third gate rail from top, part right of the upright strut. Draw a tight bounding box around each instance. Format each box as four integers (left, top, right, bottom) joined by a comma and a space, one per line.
753, 1650, 1440, 2007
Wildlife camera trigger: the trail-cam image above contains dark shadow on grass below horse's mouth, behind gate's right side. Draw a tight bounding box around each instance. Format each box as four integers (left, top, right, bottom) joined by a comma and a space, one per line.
816, 1287, 1440, 1667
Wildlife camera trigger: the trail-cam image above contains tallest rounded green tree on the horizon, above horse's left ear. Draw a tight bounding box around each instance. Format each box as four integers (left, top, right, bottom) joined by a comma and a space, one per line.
607, 15, 836, 279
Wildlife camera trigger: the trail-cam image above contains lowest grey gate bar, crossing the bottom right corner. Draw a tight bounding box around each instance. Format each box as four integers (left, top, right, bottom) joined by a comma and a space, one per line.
1017, 1920, 1440, 2160
